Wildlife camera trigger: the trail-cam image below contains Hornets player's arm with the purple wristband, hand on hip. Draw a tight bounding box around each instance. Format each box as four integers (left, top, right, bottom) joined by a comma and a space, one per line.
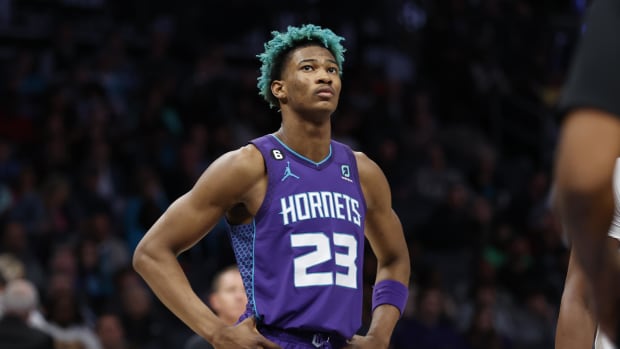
353, 153, 411, 348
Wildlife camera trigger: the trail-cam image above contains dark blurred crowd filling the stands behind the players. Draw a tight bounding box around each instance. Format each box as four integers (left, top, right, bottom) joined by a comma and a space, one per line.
0, 0, 585, 349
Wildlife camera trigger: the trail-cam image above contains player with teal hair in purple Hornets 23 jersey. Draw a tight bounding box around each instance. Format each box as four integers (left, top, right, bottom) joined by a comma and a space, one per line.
133, 24, 410, 349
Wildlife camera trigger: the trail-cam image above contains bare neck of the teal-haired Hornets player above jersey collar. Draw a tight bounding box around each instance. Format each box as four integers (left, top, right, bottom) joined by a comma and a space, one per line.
274, 121, 331, 162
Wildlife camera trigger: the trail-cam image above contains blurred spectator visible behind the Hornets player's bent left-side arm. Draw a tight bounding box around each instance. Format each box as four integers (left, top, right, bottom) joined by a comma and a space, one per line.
185, 265, 248, 349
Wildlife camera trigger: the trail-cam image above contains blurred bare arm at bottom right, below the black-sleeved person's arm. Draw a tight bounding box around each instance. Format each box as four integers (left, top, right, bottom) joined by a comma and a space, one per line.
555, 246, 596, 349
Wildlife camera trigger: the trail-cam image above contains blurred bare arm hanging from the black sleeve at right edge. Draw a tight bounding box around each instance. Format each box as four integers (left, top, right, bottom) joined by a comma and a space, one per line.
555, 109, 620, 335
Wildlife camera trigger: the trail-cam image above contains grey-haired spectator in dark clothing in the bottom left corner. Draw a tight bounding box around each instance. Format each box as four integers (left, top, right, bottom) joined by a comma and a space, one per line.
0, 279, 54, 349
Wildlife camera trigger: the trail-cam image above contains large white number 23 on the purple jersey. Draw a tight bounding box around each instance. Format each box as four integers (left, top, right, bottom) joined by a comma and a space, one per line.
291, 233, 357, 288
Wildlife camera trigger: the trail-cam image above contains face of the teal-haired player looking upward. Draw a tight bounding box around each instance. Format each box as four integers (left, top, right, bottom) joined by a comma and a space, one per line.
282, 46, 341, 114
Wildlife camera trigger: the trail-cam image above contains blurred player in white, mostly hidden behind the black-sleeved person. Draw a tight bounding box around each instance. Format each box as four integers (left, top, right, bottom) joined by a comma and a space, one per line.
555, 158, 620, 349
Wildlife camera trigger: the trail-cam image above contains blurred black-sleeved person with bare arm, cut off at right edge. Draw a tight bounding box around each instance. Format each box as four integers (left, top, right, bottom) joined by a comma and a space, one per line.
555, 0, 620, 341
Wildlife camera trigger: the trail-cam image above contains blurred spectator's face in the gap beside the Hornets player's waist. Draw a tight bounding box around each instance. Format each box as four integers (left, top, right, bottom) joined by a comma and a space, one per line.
211, 270, 248, 324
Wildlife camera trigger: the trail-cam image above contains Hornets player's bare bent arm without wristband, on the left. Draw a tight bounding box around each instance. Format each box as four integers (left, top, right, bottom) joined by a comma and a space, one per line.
133, 146, 277, 348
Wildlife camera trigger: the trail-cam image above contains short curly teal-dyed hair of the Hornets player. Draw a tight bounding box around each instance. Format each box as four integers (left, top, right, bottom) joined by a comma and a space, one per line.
256, 24, 346, 108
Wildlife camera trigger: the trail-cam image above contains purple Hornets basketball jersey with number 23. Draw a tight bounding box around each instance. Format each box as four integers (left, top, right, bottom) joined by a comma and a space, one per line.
230, 135, 366, 338
